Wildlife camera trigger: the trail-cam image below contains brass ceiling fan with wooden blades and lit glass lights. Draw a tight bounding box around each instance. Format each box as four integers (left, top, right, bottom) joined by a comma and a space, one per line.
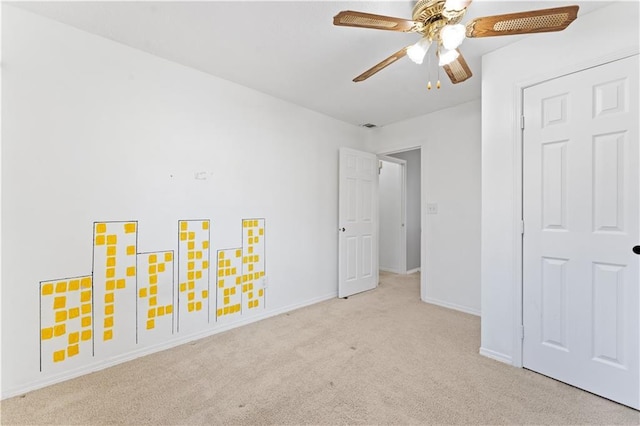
333, 0, 578, 88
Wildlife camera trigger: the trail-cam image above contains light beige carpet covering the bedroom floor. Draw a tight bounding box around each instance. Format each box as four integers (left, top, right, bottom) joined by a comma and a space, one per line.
1, 274, 640, 425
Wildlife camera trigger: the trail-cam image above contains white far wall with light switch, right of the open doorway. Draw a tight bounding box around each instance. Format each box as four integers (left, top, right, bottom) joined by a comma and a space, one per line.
369, 100, 480, 314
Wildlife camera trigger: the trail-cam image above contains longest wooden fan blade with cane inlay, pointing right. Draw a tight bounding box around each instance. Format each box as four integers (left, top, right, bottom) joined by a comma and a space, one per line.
467, 6, 579, 37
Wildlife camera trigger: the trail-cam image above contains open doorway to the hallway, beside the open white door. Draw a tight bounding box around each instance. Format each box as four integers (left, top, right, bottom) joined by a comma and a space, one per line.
379, 148, 421, 274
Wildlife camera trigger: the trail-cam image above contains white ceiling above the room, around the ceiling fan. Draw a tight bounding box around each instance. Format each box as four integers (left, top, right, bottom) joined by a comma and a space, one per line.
9, 0, 610, 126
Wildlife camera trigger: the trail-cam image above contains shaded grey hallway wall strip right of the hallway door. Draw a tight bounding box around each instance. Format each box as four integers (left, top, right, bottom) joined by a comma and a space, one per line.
389, 149, 422, 271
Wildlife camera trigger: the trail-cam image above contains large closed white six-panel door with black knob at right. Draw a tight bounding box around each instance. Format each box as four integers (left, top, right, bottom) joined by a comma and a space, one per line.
523, 56, 640, 408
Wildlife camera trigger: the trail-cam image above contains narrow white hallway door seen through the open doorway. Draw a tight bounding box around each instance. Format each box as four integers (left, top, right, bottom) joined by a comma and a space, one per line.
378, 156, 407, 274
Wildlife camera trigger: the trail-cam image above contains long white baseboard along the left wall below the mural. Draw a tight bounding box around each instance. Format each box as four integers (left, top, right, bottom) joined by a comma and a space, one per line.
0, 292, 338, 399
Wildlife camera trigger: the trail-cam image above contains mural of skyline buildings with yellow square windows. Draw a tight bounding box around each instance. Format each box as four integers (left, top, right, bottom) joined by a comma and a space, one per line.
39, 219, 266, 371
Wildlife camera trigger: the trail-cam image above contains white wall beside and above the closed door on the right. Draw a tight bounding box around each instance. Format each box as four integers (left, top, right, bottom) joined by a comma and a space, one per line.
481, 2, 639, 365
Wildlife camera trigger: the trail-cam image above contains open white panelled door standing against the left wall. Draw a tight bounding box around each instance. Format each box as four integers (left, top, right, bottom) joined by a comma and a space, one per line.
338, 148, 378, 297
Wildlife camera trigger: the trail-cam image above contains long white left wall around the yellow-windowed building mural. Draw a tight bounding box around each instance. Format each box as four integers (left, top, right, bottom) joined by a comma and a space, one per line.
2, 4, 364, 397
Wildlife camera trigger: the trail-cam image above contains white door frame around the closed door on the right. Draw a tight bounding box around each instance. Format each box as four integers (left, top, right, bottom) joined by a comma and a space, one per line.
511, 49, 639, 368
